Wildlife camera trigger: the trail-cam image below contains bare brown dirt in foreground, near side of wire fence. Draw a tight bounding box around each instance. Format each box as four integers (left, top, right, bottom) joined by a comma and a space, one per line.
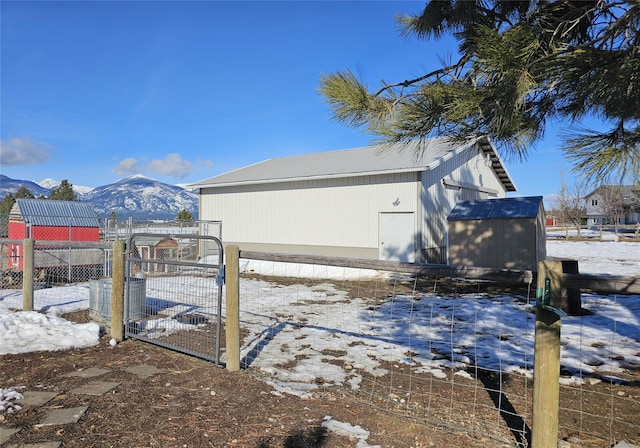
0, 326, 487, 448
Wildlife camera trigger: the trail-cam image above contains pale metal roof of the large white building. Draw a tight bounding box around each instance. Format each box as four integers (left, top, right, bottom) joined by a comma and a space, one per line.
190, 138, 515, 191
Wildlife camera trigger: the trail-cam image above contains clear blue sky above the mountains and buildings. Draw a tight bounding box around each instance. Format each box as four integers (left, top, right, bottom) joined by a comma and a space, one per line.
0, 1, 573, 200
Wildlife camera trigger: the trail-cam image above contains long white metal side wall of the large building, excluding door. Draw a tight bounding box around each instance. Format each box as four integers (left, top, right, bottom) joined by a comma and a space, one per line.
200, 173, 419, 248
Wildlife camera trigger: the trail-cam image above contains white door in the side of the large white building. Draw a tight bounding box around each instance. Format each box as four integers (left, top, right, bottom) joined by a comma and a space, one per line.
378, 212, 416, 263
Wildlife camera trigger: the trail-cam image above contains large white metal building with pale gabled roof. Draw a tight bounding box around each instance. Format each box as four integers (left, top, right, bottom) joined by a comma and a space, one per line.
191, 138, 515, 263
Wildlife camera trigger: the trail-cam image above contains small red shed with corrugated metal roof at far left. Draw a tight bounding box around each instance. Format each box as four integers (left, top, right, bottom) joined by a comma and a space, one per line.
8, 198, 100, 270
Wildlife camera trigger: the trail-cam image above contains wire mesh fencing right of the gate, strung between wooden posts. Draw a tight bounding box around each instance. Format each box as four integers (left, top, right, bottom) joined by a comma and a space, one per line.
235, 257, 640, 447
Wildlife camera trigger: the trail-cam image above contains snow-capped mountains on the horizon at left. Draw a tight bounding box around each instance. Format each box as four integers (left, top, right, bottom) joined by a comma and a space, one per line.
0, 175, 198, 220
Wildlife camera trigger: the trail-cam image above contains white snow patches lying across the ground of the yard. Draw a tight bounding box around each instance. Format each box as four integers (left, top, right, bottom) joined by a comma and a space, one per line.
0, 240, 640, 447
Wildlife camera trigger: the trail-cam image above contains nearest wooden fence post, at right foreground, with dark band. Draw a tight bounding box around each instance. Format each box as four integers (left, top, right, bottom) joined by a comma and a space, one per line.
531, 260, 562, 448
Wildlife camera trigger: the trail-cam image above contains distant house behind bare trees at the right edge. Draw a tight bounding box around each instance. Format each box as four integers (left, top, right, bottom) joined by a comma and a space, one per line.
585, 185, 640, 225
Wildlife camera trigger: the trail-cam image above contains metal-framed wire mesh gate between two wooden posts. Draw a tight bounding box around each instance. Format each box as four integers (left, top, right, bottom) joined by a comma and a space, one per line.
124, 233, 224, 364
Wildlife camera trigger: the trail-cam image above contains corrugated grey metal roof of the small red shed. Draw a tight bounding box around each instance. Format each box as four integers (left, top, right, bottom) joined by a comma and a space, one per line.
16, 198, 100, 227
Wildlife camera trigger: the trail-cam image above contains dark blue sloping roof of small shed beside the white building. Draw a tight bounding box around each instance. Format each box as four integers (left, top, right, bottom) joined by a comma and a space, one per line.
448, 196, 542, 221
